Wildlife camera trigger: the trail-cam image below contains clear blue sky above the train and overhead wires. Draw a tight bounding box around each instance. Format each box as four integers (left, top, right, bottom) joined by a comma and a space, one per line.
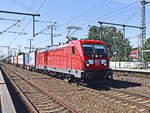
0, 0, 150, 55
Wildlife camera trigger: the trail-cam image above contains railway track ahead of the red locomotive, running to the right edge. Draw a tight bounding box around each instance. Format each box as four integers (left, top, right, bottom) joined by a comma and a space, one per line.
85, 83, 150, 112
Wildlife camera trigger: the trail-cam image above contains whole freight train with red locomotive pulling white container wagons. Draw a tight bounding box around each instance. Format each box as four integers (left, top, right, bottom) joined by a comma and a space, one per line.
11, 40, 113, 81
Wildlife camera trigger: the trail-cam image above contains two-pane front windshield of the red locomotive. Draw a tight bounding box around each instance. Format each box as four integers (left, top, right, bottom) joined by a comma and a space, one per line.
82, 44, 106, 57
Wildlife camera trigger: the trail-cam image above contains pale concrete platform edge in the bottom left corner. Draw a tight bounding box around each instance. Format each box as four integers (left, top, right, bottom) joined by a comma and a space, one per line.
0, 70, 16, 113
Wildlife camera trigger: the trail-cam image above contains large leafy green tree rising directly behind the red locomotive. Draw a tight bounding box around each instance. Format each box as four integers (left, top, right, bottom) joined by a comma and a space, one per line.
88, 26, 132, 61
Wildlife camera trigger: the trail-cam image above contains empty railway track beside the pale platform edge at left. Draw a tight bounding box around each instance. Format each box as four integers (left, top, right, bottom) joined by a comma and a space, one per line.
0, 66, 79, 113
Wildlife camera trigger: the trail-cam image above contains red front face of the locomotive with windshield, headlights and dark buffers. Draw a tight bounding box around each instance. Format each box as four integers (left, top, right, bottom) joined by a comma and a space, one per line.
81, 40, 113, 80
